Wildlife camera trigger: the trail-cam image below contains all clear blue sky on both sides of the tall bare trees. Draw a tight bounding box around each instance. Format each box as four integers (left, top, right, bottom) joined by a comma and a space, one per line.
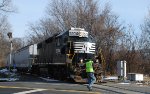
9, 0, 150, 38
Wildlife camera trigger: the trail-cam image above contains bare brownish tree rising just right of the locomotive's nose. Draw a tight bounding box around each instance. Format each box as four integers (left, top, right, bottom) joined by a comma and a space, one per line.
92, 5, 125, 74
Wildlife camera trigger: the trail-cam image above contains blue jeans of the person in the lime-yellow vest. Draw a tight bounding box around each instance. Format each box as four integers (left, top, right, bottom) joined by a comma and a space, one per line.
87, 72, 96, 89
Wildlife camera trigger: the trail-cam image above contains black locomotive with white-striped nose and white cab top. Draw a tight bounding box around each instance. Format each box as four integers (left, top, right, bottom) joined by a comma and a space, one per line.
10, 28, 102, 82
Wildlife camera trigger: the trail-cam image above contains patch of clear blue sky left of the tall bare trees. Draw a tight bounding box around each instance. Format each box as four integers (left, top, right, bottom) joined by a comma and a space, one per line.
8, 0, 49, 38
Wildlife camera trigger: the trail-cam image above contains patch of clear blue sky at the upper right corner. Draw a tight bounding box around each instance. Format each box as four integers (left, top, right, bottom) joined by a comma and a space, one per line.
107, 0, 150, 35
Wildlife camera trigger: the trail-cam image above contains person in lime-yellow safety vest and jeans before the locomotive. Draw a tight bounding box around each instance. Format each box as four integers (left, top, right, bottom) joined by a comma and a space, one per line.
86, 59, 96, 91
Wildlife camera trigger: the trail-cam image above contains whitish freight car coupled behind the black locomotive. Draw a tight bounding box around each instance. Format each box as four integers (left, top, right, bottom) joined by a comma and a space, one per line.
7, 44, 37, 69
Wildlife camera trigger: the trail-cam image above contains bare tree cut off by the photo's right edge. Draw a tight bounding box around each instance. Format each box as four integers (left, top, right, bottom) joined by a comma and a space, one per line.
140, 10, 150, 75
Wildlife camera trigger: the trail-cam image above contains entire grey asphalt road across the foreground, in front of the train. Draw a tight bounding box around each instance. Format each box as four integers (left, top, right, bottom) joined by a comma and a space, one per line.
0, 75, 150, 94
